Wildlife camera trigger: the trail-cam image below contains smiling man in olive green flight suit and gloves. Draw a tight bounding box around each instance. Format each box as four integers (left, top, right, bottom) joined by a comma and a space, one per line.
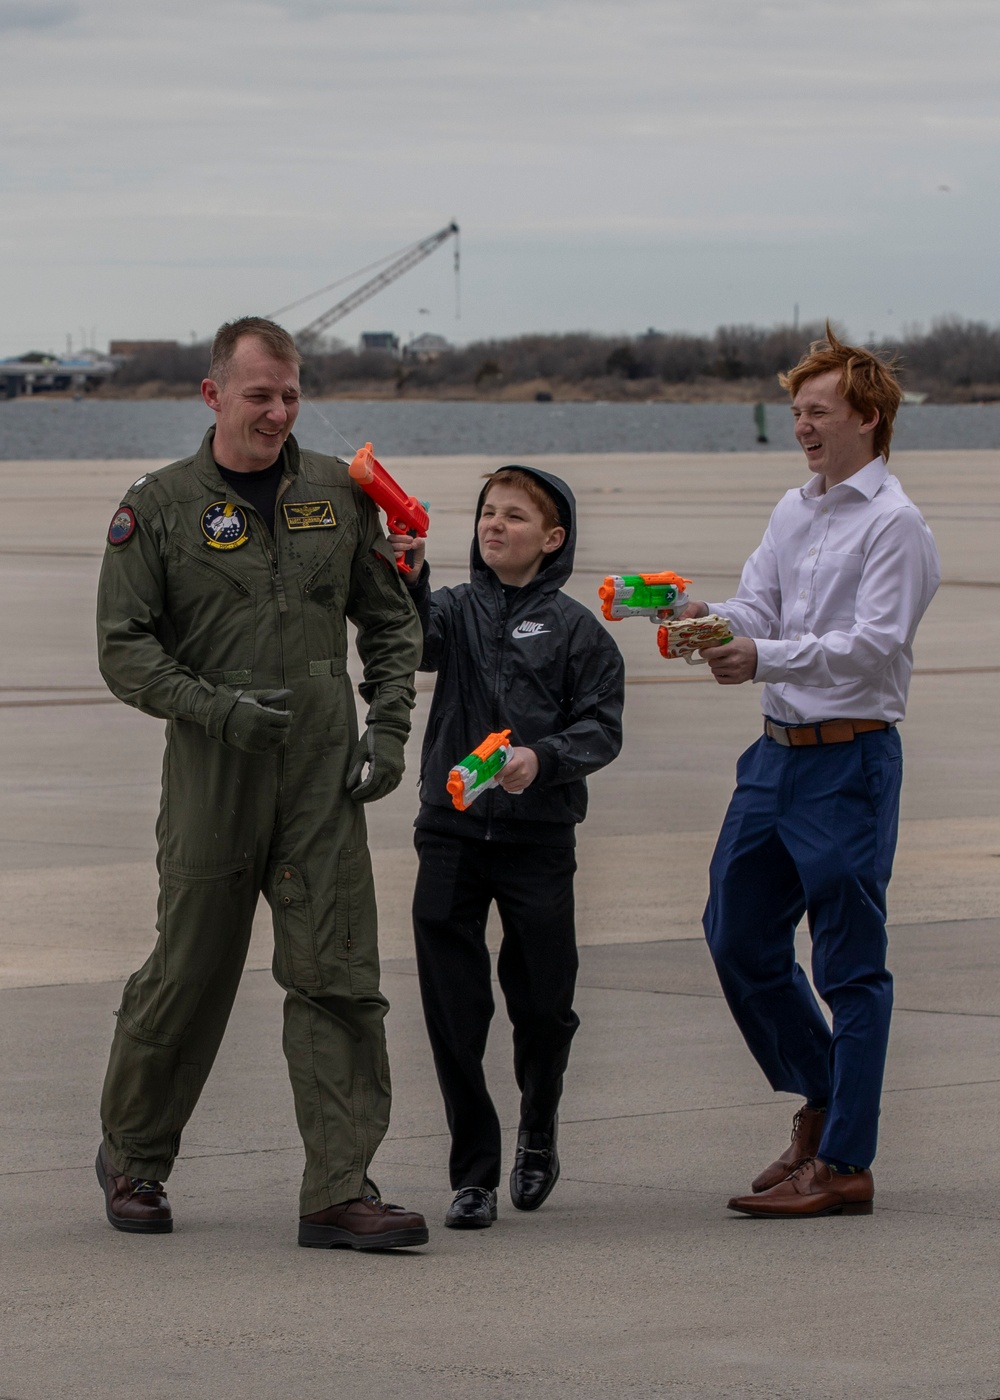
97, 316, 427, 1249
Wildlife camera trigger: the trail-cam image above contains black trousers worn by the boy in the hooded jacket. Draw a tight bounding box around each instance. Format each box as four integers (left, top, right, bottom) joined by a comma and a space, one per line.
413, 832, 580, 1190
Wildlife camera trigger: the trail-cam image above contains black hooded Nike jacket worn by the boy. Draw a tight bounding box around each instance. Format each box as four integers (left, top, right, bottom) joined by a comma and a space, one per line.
412, 466, 625, 846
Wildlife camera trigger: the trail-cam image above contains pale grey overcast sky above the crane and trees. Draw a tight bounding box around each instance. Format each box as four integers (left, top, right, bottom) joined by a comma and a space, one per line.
0, 0, 1000, 354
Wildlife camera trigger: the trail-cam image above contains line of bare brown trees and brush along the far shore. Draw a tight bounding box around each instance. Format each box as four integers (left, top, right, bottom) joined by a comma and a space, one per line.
109, 318, 1000, 400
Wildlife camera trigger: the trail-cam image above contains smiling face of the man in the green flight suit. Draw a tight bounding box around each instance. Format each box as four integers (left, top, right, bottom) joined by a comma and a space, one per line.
202, 335, 300, 472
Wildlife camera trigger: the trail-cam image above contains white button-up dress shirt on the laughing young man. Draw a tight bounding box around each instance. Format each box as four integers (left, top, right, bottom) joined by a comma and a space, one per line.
709, 456, 941, 724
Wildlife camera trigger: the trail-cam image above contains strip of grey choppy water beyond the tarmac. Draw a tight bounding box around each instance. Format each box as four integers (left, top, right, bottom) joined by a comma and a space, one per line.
0, 398, 1000, 461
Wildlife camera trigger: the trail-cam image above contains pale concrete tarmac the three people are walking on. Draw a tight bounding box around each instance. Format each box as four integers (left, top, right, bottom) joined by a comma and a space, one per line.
0, 452, 1000, 1400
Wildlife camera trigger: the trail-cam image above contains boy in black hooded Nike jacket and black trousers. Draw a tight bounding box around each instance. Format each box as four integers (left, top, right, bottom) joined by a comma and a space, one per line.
392, 466, 625, 1229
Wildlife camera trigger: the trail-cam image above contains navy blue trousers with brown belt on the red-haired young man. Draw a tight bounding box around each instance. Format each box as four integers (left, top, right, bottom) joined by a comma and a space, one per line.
704, 729, 903, 1166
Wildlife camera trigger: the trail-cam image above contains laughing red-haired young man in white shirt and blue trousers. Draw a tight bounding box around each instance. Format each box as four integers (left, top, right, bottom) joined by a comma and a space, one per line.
688, 326, 940, 1217
